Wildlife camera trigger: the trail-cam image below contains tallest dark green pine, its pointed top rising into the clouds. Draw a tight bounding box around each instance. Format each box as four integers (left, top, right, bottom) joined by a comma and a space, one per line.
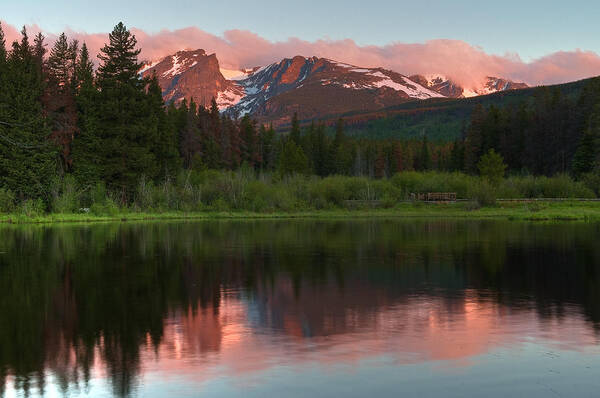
72, 23, 160, 201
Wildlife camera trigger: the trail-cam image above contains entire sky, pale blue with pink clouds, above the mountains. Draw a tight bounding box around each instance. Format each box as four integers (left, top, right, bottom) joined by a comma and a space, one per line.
0, 0, 600, 84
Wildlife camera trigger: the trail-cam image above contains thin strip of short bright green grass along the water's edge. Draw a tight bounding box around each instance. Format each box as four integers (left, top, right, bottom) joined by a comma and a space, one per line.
0, 201, 600, 224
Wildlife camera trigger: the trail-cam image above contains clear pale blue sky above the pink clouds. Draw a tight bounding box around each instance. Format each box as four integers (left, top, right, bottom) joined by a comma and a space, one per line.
0, 0, 600, 61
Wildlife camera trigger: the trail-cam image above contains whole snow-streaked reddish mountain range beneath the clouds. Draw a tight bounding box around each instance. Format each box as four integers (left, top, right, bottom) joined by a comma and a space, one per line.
140, 50, 527, 125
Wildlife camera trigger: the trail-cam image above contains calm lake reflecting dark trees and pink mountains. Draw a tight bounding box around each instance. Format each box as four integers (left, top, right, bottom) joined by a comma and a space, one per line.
0, 220, 600, 397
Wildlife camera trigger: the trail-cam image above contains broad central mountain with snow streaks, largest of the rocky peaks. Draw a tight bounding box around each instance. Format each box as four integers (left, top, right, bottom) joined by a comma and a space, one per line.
228, 56, 443, 116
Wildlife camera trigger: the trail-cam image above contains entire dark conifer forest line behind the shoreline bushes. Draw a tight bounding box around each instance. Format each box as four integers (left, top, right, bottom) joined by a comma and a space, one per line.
0, 23, 600, 208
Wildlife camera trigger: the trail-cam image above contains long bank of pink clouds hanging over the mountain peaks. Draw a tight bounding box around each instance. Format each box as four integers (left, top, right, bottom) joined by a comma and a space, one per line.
2, 23, 600, 87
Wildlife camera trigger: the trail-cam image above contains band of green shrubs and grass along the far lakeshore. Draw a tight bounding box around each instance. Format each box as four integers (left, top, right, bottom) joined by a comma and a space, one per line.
0, 168, 600, 223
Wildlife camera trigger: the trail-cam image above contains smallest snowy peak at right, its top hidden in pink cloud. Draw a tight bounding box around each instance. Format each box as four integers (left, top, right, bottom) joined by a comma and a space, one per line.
410, 75, 528, 98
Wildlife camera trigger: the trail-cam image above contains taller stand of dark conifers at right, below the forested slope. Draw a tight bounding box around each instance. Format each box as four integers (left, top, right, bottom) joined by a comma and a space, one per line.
452, 78, 600, 176
